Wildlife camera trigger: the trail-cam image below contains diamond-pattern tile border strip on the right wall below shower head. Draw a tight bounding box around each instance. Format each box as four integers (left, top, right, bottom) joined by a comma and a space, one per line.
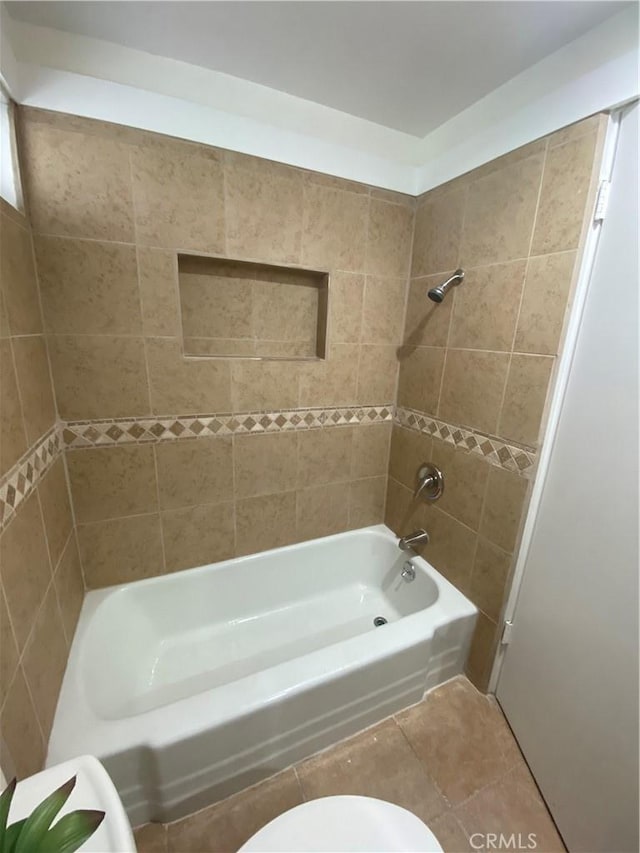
394, 407, 537, 479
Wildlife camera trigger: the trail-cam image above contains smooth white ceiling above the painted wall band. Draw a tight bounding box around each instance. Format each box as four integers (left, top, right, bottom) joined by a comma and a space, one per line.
6, 0, 634, 137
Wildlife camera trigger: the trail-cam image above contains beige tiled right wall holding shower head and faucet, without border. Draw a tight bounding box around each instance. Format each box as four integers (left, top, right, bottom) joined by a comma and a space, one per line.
386, 116, 606, 688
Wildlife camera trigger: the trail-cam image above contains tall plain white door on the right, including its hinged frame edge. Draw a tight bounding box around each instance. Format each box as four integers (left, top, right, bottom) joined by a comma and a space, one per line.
497, 104, 640, 853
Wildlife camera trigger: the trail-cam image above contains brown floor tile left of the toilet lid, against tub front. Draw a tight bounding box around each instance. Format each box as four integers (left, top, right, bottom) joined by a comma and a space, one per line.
168, 770, 302, 853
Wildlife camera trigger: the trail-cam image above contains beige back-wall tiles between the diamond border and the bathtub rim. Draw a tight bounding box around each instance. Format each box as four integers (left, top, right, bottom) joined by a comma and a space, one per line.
67, 423, 391, 588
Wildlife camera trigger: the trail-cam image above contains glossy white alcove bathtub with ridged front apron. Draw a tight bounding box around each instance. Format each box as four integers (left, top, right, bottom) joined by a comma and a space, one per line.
47, 525, 476, 825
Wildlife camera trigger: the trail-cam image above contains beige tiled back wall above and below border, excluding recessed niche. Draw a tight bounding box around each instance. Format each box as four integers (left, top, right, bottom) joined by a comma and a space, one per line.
21, 109, 415, 587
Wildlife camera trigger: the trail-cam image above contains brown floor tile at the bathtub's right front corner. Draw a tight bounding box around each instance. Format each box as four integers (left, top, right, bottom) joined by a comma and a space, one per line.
396, 678, 520, 805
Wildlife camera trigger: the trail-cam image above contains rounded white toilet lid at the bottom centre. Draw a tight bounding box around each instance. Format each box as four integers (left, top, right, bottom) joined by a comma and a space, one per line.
239, 796, 443, 853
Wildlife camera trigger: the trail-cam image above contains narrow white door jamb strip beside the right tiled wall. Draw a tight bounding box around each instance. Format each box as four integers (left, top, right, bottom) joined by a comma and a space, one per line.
488, 111, 621, 693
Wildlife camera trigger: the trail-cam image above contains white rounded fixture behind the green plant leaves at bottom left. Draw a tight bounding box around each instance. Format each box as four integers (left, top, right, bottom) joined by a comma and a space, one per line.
9, 755, 136, 853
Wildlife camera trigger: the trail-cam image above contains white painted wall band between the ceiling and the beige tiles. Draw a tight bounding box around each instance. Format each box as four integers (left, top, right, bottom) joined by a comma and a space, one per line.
0, 7, 640, 194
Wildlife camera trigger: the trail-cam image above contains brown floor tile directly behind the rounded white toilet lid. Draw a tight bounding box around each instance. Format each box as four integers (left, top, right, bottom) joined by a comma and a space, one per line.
298, 720, 445, 822
